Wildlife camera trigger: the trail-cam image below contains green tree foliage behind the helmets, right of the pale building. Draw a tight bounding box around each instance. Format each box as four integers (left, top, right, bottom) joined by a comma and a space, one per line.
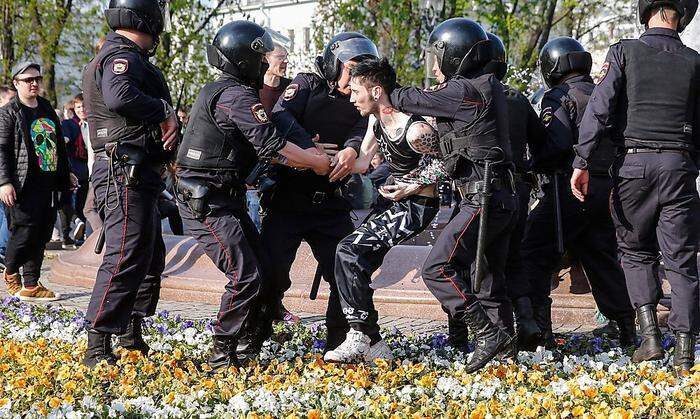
314, 0, 636, 88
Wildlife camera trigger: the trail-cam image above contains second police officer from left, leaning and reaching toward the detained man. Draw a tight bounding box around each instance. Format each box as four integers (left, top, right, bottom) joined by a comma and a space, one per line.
177, 21, 330, 369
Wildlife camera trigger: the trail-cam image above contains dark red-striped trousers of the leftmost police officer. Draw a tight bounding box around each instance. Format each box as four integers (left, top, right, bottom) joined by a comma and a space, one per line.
85, 159, 165, 333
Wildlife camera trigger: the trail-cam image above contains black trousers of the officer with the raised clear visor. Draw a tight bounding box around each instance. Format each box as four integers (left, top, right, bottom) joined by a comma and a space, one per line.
261, 208, 355, 338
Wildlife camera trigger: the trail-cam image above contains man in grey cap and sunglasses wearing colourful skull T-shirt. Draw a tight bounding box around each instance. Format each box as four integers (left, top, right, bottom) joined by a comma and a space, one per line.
0, 62, 71, 301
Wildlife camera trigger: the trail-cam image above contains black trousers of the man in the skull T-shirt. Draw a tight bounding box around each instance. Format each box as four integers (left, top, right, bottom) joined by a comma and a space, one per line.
5, 189, 58, 287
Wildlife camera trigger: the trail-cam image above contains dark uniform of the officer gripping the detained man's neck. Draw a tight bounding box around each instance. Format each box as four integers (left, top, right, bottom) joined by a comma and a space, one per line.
391, 74, 517, 325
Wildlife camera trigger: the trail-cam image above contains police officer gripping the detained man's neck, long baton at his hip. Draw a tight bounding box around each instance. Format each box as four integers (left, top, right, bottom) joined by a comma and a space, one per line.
391, 18, 516, 372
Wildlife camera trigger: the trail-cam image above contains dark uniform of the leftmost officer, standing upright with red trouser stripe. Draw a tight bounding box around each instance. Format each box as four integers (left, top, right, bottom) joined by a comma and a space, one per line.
83, 32, 171, 333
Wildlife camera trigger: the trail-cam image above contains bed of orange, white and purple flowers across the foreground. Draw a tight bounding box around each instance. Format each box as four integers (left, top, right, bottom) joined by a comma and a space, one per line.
0, 299, 700, 418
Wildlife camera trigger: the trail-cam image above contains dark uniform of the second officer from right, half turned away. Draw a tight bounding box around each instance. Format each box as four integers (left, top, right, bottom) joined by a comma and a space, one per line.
514, 76, 634, 327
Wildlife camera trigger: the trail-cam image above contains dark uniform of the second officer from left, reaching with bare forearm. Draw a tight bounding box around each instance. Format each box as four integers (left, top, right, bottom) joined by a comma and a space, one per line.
177, 73, 286, 337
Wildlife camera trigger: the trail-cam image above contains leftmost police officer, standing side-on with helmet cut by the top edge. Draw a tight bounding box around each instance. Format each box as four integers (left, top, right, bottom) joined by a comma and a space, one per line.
83, 0, 178, 367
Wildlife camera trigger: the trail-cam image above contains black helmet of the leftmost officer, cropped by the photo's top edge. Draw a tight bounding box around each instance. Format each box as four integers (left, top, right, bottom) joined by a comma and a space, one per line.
105, 0, 170, 37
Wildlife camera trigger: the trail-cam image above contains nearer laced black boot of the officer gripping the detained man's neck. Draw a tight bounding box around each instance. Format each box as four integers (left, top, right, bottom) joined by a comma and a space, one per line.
464, 302, 513, 373
